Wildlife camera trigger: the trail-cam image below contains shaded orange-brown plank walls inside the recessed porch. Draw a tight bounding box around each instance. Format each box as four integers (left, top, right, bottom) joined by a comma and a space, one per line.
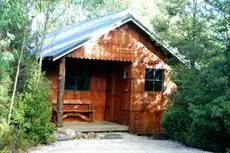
43, 58, 130, 122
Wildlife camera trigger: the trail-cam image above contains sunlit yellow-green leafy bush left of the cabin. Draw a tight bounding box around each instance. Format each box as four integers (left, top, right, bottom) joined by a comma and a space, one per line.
0, 57, 54, 152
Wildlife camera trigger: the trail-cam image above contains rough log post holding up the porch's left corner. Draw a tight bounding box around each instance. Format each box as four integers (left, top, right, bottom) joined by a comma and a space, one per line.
56, 57, 65, 127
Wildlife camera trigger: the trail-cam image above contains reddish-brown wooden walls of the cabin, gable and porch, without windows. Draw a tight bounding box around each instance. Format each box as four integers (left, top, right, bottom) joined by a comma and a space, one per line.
44, 23, 176, 134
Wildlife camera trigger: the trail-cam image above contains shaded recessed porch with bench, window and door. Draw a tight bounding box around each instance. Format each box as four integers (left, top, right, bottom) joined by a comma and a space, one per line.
46, 58, 132, 126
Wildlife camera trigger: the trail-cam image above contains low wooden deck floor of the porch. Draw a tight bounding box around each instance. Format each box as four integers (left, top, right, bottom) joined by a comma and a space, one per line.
59, 121, 128, 132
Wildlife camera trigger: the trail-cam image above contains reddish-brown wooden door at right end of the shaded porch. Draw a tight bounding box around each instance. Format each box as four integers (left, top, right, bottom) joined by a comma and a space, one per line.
106, 66, 130, 125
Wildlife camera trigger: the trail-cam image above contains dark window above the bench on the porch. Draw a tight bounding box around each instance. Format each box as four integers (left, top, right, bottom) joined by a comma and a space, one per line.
65, 65, 91, 91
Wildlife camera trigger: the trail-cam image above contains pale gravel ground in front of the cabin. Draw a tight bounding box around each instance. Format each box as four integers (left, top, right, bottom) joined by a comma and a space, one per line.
29, 133, 212, 153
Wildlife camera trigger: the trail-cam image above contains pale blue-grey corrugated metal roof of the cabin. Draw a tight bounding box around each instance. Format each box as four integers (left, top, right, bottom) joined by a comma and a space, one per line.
42, 10, 188, 63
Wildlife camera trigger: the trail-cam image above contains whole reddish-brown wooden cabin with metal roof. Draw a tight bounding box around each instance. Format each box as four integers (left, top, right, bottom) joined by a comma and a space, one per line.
43, 11, 181, 134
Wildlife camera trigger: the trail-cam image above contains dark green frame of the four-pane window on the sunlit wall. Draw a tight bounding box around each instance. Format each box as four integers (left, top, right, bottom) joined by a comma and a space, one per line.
144, 68, 165, 92
